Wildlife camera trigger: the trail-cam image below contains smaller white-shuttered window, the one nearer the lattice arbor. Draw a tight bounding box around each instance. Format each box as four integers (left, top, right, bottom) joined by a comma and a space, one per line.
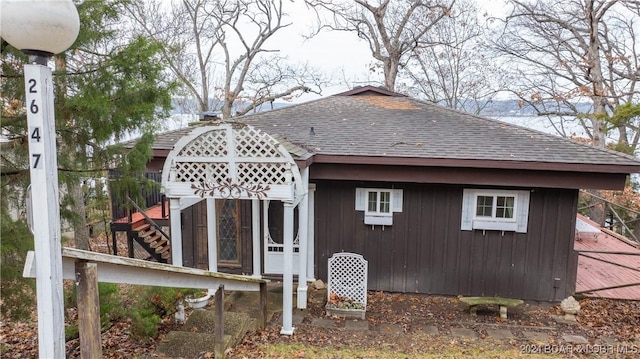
356, 188, 402, 226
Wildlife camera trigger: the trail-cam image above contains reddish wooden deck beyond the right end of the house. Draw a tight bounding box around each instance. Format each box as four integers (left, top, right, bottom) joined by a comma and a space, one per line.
574, 215, 640, 300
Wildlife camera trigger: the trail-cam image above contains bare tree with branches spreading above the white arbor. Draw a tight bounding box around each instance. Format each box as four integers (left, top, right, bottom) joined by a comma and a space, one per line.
129, 0, 324, 118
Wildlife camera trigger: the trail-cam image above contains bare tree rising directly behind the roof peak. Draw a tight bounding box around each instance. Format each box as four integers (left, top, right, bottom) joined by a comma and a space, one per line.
305, 0, 455, 91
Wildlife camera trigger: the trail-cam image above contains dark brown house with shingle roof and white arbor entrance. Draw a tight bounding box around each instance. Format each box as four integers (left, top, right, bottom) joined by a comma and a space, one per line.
115, 86, 640, 334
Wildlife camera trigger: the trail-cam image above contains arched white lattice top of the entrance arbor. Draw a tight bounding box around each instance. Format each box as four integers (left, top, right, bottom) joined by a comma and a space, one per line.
162, 122, 303, 201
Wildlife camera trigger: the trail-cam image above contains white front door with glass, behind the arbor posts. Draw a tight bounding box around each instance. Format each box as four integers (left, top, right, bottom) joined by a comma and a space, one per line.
264, 201, 300, 274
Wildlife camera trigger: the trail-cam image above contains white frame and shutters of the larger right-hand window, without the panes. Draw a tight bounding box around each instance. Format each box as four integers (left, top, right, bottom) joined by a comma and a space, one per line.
460, 188, 530, 233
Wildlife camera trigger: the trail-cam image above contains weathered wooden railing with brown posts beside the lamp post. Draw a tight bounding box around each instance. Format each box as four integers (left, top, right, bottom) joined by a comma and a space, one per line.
23, 247, 269, 358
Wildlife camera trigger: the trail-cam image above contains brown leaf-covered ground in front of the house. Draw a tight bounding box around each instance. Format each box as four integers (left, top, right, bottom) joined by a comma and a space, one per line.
0, 233, 640, 358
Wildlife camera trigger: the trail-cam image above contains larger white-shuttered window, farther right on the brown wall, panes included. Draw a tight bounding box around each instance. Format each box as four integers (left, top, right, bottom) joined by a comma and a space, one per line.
461, 189, 529, 233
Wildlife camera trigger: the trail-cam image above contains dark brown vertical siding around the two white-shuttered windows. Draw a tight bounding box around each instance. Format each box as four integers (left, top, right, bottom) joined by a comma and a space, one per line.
315, 181, 577, 300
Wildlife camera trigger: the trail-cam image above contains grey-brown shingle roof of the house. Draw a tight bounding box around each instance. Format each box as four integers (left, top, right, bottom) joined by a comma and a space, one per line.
148, 88, 640, 173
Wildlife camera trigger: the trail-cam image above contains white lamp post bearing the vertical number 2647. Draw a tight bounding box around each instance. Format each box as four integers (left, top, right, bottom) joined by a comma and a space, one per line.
24, 57, 65, 358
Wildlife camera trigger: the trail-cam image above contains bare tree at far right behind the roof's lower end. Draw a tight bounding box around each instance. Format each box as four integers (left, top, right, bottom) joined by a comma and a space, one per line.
494, 0, 640, 147
